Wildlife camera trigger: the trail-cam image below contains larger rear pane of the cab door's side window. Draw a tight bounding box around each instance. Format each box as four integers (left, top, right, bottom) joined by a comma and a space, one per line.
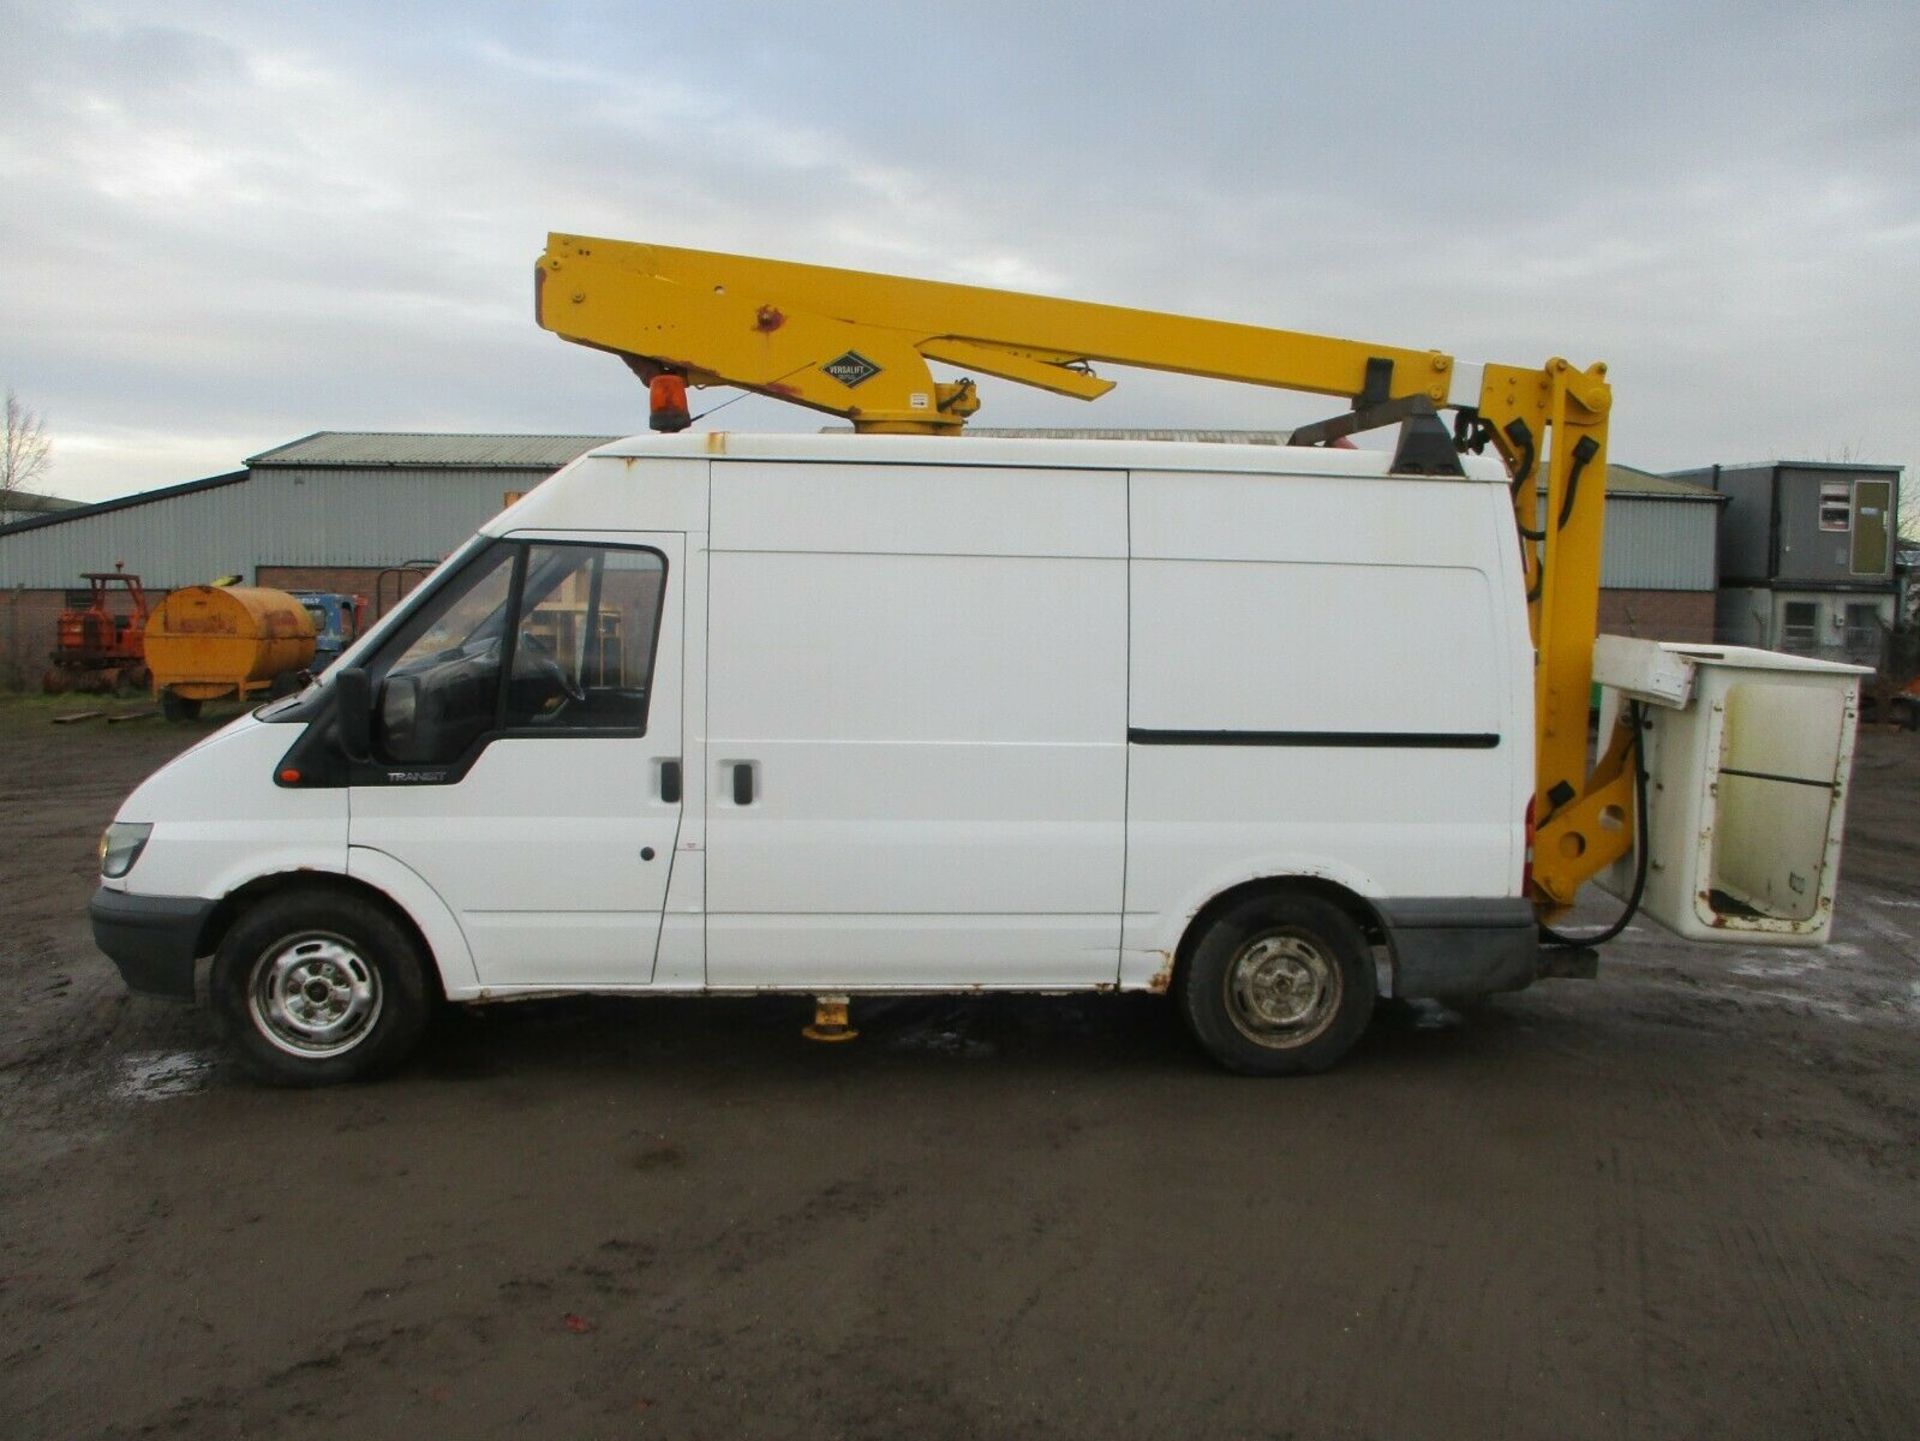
505, 545, 666, 731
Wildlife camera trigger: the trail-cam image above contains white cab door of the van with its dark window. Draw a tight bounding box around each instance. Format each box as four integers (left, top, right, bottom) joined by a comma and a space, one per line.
349, 533, 685, 988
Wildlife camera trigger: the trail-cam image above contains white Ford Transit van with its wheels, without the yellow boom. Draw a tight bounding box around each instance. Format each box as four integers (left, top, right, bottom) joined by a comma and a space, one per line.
90, 434, 1540, 1084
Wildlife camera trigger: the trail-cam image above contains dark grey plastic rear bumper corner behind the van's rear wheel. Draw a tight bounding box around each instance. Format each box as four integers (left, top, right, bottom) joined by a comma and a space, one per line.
1380, 898, 1542, 1000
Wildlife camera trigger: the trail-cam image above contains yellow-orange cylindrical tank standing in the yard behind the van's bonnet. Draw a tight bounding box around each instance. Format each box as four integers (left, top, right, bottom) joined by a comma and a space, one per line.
146, 585, 313, 720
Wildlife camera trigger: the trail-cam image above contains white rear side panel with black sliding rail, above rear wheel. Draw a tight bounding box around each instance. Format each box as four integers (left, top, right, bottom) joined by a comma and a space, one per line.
1121, 470, 1532, 984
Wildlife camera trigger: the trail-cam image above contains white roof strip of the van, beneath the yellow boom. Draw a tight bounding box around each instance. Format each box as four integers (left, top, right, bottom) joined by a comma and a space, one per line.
582, 430, 1507, 484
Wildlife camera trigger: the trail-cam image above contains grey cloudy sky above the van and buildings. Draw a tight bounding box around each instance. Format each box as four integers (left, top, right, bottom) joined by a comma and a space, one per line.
0, 0, 1920, 514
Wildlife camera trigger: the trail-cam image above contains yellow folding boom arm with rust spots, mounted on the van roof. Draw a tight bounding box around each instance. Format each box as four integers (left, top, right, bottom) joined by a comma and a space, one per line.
534, 234, 1634, 919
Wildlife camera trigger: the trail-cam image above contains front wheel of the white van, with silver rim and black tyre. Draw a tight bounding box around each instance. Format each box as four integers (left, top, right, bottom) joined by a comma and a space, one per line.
211, 888, 428, 1086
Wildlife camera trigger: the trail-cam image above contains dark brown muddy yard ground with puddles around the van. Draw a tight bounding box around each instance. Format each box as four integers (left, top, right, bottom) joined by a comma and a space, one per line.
0, 702, 1920, 1441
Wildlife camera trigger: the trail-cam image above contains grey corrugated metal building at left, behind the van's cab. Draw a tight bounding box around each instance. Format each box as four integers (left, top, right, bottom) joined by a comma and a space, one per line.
0, 432, 616, 685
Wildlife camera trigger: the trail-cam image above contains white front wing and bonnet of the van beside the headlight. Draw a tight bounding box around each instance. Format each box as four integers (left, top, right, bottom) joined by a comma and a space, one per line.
104, 716, 348, 900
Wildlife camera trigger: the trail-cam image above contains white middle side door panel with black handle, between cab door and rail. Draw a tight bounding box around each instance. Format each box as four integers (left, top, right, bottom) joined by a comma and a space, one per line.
707, 461, 1127, 988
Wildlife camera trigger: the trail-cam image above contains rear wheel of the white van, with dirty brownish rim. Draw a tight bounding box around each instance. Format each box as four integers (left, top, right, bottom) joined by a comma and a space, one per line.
1177, 894, 1377, 1076
